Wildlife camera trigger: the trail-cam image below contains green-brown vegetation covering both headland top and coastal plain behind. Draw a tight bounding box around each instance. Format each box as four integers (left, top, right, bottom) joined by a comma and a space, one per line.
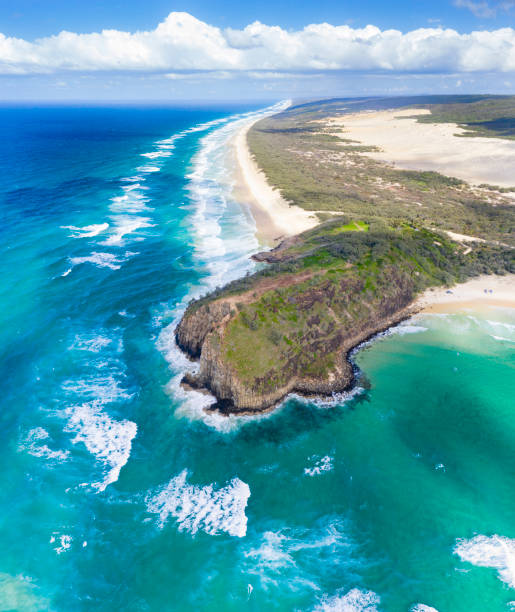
183, 99, 515, 402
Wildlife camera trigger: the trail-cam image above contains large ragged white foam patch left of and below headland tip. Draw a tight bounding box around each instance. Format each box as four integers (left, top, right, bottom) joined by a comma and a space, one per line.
65, 400, 138, 491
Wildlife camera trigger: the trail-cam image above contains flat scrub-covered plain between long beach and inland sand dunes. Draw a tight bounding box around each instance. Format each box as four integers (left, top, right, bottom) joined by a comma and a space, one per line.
248, 97, 515, 245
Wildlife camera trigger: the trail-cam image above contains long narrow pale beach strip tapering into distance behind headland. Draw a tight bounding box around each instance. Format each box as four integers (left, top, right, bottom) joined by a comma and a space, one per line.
233, 122, 319, 245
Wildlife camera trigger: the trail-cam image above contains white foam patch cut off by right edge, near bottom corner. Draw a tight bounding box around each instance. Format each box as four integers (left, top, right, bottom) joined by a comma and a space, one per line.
454, 535, 515, 589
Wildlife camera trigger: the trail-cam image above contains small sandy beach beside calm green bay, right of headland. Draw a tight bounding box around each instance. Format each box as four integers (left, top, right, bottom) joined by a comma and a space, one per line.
415, 274, 515, 313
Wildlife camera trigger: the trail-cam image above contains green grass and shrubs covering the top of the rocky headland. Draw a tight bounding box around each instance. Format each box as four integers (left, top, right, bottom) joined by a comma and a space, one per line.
217, 222, 515, 393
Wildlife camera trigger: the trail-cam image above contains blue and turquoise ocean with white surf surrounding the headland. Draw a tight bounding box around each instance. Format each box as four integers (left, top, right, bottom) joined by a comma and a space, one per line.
0, 107, 515, 612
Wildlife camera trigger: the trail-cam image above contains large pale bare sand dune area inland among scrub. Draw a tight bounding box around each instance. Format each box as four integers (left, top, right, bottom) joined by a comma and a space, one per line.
331, 108, 515, 187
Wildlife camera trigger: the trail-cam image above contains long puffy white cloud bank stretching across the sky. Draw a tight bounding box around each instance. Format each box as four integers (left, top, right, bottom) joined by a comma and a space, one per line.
0, 11, 515, 78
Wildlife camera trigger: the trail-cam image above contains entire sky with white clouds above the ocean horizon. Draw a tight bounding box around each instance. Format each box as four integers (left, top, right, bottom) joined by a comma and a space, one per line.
0, 0, 515, 101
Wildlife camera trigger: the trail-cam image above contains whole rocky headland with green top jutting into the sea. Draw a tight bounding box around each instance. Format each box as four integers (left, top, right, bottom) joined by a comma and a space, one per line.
176, 219, 512, 414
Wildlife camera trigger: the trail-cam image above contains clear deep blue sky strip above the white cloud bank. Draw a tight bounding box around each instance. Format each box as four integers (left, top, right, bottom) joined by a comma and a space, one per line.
4, 0, 515, 40
